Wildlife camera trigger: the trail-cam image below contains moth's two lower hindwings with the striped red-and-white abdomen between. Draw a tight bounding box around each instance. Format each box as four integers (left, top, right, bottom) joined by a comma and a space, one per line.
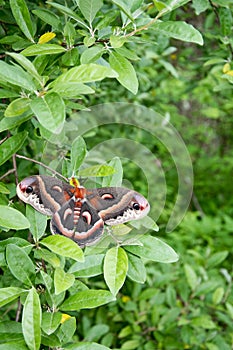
50, 197, 104, 247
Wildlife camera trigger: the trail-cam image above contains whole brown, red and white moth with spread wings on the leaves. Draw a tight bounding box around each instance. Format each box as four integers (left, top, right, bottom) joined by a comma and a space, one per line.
17, 175, 150, 247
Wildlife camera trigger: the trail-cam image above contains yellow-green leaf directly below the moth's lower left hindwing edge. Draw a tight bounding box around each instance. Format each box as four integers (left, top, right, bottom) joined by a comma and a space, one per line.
40, 235, 84, 261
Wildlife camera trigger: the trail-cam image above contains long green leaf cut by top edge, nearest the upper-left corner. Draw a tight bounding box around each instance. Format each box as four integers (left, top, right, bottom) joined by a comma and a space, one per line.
10, 0, 34, 42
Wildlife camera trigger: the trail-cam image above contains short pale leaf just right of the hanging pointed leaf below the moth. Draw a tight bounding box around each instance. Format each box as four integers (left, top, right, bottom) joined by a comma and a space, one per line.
127, 253, 146, 283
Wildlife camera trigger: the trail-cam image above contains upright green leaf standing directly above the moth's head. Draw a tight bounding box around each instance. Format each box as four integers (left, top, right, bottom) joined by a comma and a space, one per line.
70, 136, 87, 174
